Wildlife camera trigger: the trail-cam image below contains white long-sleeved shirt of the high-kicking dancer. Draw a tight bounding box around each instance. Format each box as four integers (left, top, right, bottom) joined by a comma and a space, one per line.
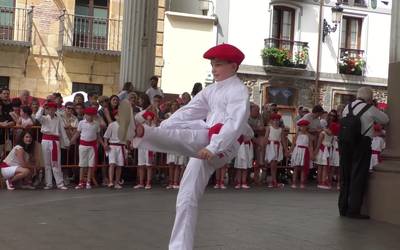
160, 75, 253, 154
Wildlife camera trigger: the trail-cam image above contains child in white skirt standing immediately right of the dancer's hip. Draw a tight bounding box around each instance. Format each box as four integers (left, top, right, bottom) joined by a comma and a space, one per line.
234, 136, 254, 189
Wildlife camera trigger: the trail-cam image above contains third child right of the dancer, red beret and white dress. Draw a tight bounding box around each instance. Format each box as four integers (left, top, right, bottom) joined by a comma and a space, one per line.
291, 120, 313, 188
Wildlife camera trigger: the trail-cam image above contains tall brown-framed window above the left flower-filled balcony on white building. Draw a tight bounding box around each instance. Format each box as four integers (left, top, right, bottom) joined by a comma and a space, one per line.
272, 6, 295, 50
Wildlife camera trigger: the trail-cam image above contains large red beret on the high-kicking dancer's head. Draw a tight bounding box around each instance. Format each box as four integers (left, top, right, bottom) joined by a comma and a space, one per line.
203, 43, 244, 65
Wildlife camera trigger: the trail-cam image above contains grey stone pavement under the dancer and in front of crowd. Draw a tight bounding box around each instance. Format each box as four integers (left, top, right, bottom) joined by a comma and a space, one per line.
0, 188, 400, 250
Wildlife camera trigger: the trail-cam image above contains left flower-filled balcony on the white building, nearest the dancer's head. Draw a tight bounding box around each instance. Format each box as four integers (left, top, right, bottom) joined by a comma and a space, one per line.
261, 38, 308, 69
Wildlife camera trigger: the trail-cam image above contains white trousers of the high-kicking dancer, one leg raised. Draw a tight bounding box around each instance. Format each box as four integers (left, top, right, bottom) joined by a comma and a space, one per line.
133, 126, 239, 250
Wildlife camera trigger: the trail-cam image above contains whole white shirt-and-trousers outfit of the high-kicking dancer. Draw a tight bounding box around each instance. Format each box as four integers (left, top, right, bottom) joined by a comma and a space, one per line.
132, 75, 253, 250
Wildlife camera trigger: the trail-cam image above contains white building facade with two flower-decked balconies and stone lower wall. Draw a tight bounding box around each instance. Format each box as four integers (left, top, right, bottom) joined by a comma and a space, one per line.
159, 0, 391, 129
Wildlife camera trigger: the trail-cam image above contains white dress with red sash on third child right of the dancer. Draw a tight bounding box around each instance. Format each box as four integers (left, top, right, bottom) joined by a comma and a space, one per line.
291, 134, 310, 167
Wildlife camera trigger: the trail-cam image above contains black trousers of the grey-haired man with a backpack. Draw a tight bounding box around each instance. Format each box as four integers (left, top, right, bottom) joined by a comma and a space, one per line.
338, 136, 371, 216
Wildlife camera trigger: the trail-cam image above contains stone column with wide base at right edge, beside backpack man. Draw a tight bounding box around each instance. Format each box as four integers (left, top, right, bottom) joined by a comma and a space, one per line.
366, 1, 400, 225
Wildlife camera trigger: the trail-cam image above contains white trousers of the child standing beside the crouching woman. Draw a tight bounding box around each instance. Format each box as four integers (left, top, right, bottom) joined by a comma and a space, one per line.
42, 140, 64, 187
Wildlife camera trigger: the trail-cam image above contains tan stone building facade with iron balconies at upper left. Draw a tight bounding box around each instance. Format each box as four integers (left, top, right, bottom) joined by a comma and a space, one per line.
0, 0, 123, 97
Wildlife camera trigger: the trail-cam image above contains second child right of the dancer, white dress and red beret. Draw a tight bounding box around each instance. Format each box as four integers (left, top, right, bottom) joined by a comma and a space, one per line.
265, 114, 288, 188
